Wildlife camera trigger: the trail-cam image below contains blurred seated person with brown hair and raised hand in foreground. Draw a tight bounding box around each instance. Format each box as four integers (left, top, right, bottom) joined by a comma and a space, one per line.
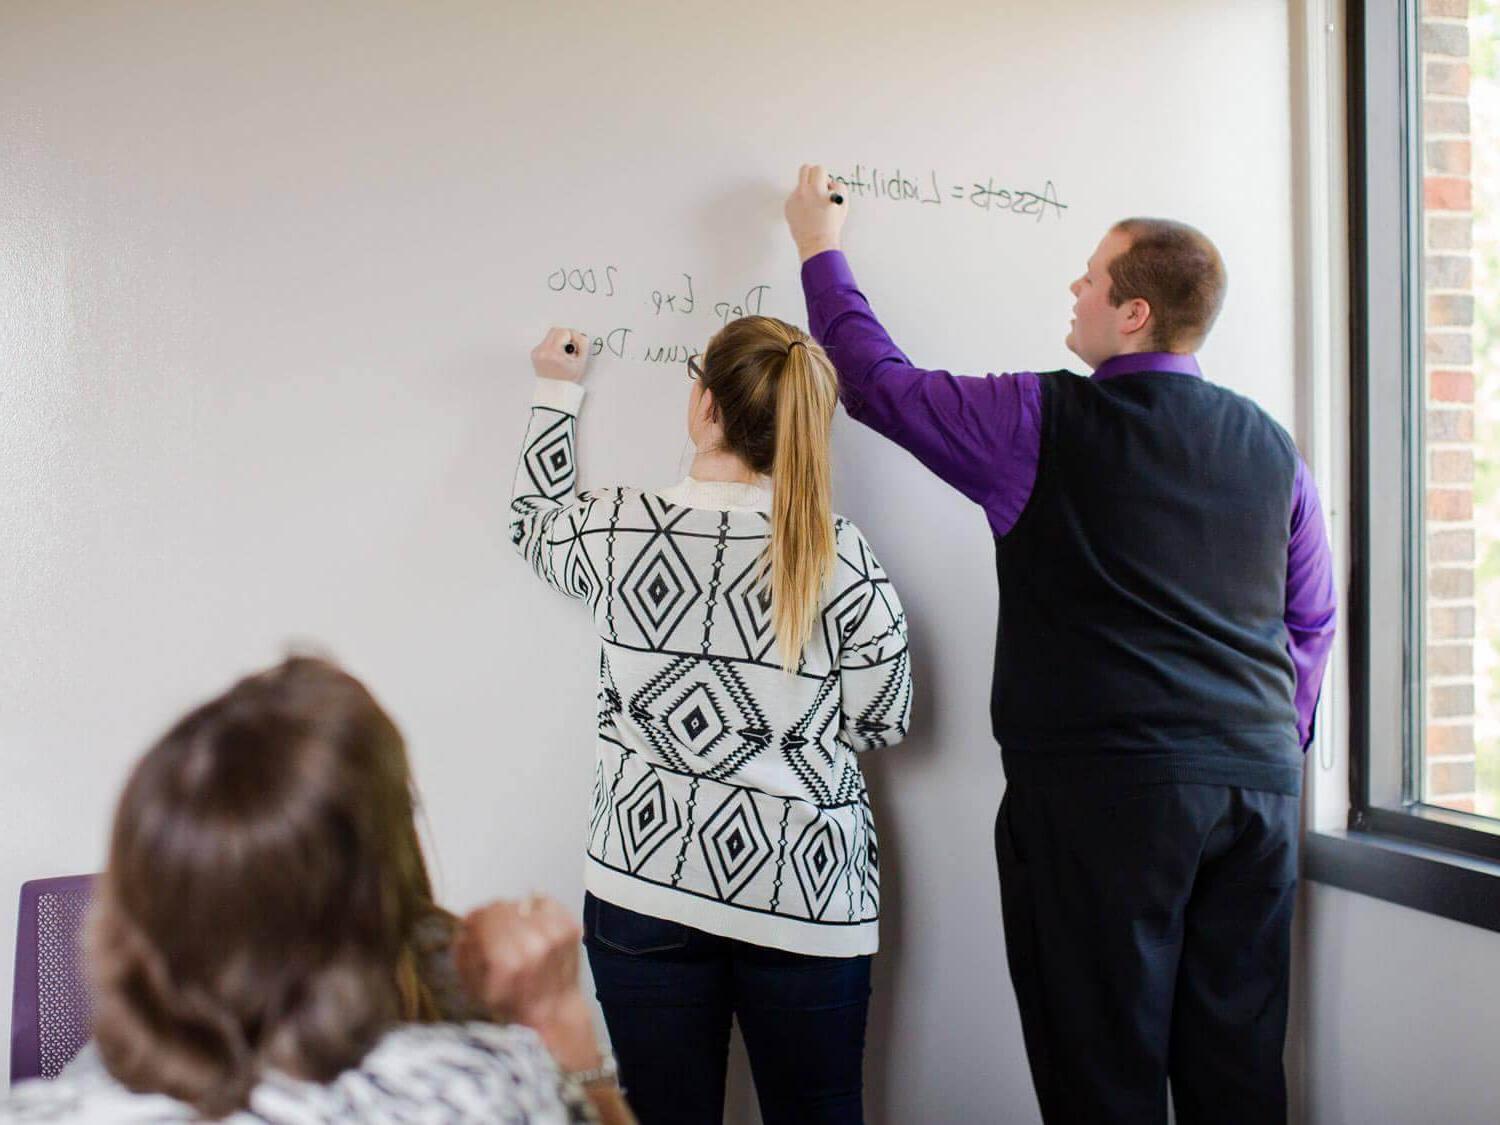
0, 657, 633, 1125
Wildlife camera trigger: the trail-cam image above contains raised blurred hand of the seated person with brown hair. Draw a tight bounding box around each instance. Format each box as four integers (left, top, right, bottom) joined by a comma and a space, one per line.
453, 900, 602, 1071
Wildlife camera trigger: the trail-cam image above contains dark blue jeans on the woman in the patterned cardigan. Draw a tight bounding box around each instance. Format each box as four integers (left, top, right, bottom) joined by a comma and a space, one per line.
584, 894, 870, 1125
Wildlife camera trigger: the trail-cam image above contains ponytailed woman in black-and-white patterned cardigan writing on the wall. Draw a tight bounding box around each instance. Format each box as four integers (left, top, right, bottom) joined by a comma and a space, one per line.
512, 317, 911, 1125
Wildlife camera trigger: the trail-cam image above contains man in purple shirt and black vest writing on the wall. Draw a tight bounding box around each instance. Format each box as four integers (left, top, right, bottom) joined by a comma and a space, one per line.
786, 165, 1335, 1125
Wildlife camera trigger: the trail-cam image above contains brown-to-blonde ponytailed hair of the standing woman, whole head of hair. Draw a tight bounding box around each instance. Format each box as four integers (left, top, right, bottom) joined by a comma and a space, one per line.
704, 317, 839, 671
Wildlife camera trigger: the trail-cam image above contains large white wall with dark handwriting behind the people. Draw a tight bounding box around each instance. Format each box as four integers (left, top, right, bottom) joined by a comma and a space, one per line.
0, 0, 1298, 1122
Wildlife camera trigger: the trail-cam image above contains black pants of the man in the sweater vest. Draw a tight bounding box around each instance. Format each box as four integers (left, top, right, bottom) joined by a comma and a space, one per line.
995, 783, 1298, 1125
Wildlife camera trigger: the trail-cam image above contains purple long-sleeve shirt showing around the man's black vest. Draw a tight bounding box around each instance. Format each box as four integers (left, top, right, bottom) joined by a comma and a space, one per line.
803, 251, 1337, 747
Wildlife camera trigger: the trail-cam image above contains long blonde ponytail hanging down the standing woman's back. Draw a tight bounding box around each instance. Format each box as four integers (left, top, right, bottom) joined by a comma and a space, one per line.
768, 341, 839, 672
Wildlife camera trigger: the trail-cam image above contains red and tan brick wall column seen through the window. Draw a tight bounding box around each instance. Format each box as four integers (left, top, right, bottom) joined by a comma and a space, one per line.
1421, 0, 1475, 812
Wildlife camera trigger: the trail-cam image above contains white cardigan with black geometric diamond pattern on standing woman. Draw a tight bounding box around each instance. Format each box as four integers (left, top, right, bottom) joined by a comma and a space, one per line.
512, 380, 912, 957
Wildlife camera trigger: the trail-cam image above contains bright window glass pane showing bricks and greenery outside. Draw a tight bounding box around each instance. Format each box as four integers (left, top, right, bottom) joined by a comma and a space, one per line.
1415, 0, 1500, 818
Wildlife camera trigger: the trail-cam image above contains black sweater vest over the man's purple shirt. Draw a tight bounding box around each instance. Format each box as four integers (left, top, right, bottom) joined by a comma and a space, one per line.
990, 372, 1302, 792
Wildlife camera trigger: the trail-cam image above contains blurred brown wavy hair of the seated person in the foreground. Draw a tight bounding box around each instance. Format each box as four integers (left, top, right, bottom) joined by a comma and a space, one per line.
89, 657, 449, 1119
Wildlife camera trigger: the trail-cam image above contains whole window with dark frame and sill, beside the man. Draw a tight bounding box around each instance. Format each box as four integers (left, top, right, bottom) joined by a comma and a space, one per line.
1308, 0, 1500, 930
